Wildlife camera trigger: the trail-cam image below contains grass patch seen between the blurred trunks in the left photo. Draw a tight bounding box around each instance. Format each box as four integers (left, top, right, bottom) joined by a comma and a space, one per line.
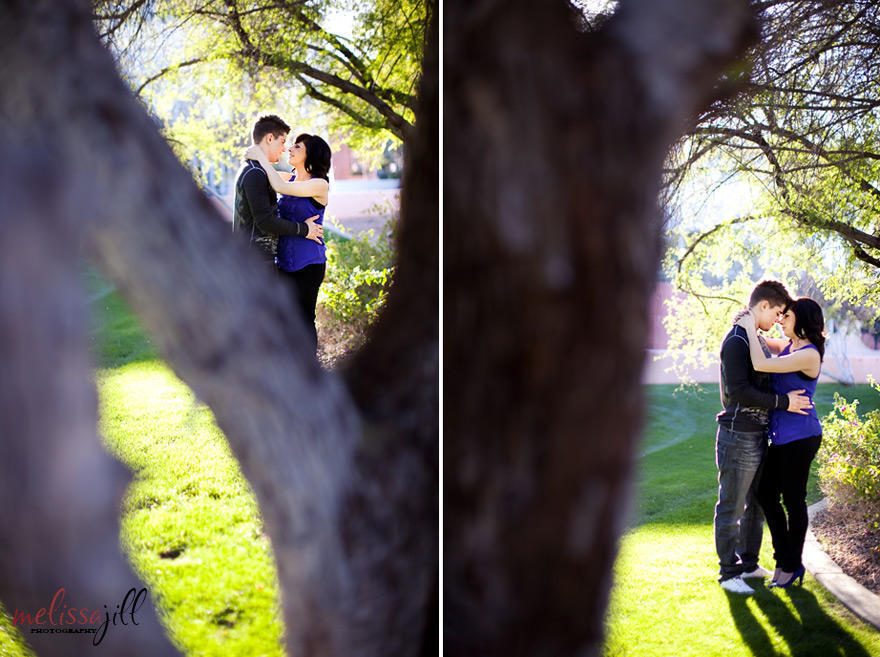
0, 272, 284, 657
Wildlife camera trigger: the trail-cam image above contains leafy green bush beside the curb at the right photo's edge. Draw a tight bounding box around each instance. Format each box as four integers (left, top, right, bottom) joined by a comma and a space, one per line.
818, 384, 880, 522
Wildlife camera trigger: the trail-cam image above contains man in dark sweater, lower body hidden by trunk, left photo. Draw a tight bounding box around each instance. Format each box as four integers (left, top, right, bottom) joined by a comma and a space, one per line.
232, 114, 324, 267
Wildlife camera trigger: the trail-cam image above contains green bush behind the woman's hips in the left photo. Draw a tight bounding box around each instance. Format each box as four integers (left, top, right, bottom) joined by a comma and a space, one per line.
318, 221, 395, 346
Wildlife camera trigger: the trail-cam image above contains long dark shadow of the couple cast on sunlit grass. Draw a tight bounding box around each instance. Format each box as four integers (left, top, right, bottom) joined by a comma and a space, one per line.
727, 586, 871, 657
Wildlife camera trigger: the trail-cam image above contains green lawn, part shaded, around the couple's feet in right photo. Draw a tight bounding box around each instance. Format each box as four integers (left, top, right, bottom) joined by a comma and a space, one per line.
603, 385, 880, 657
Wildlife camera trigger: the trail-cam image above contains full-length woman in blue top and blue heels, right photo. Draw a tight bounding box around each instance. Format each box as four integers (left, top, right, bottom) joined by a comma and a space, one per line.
737, 297, 825, 588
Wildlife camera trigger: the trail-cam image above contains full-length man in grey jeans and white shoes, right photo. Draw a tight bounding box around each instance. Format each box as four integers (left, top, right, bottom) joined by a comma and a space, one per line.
715, 281, 811, 594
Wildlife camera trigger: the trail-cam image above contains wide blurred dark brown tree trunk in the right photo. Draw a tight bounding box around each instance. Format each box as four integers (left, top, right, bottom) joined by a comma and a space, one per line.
443, 0, 755, 656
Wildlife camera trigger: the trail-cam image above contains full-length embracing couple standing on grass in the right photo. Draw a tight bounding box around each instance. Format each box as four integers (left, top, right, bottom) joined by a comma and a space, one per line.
715, 281, 825, 594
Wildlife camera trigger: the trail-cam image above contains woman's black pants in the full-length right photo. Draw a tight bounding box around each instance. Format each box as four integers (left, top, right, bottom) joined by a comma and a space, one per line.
757, 436, 822, 573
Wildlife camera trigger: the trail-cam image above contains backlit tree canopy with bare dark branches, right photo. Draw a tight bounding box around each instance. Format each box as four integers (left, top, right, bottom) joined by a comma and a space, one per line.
664, 0, 880, 364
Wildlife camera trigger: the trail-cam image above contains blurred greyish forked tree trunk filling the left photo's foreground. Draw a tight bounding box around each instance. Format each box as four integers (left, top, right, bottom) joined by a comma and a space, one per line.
0, 0, 438, 657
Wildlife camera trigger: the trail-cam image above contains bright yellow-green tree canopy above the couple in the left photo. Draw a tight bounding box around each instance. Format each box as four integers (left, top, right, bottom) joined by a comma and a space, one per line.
94, 0, 435, 169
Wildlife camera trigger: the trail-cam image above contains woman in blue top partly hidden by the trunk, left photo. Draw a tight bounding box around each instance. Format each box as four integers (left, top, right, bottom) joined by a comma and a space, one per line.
245, 134, 331, 349
